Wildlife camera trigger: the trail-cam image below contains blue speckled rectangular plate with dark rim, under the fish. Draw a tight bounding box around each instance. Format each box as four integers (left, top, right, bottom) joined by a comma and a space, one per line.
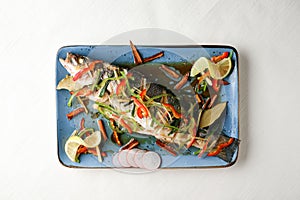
56, 45, 239, 168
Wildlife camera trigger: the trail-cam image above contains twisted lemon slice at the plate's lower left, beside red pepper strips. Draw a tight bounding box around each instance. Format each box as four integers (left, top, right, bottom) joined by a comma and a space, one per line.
65, 131, 101, 162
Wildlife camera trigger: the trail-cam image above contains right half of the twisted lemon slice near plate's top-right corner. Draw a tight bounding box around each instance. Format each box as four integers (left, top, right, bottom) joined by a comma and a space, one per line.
208, 58, 232, 79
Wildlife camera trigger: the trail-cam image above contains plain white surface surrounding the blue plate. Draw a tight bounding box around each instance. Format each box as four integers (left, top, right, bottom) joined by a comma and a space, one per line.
0, 0, 300, 200
